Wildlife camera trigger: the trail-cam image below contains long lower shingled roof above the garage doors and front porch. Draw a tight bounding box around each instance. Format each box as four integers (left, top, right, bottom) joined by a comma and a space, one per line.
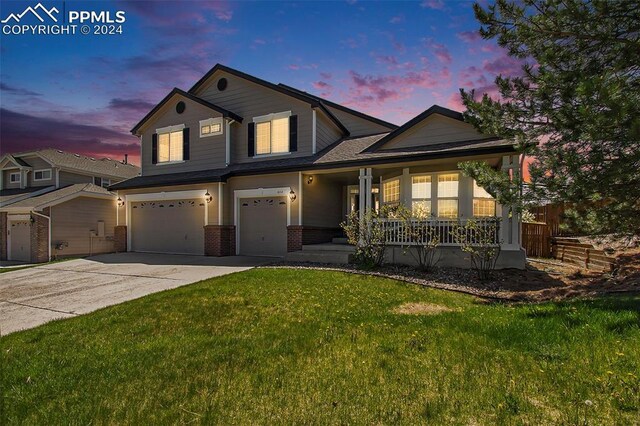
109, 133, 514, 190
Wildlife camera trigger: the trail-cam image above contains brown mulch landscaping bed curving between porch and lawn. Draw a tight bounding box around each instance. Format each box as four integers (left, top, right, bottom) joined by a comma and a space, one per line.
266, 253, 640, 302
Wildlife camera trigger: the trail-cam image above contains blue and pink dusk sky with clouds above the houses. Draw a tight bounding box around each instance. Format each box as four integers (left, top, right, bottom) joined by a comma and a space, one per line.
0, 0, 519, 163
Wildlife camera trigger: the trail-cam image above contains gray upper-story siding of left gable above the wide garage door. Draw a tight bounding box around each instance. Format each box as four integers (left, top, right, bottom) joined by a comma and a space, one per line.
141, 95, 228, 176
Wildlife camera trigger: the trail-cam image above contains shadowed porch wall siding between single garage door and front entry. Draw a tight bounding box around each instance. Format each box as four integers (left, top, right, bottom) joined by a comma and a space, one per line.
302, 175, 345, 228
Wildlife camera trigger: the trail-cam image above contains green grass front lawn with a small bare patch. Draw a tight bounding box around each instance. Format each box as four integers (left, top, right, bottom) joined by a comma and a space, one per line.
0, 269, 640, 424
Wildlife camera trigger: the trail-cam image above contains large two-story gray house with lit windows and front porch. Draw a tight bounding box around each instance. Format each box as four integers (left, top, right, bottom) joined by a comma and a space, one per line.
110, 65, 524, 267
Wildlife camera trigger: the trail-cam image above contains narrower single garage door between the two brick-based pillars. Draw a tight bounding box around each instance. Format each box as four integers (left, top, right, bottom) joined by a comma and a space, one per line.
239, 197, 287, 256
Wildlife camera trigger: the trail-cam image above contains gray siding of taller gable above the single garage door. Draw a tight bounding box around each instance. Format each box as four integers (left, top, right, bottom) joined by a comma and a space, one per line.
197, 71, 312, 163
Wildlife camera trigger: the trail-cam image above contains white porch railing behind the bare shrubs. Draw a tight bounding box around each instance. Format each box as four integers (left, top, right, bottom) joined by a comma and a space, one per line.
378, 217, 500, 246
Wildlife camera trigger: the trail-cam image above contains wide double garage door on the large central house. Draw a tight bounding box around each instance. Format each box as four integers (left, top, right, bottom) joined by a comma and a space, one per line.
131, 199, 205, 254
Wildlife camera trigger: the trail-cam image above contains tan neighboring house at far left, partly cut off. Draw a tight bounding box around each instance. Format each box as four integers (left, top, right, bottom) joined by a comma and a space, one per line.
0, 149, 140, 262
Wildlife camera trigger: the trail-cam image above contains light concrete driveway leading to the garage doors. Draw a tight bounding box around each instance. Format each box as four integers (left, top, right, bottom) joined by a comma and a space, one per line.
0, 253, 274, 335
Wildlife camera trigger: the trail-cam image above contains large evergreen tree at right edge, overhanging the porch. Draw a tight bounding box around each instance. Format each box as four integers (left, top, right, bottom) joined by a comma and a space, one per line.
461, 0, 640, 235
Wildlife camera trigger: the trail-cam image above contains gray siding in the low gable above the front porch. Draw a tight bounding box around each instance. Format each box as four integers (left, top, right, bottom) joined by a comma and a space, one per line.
380, 115, 486, 149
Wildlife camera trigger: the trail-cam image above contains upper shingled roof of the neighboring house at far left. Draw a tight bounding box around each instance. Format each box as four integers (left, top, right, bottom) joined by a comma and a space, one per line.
34, 148, 140, 179
